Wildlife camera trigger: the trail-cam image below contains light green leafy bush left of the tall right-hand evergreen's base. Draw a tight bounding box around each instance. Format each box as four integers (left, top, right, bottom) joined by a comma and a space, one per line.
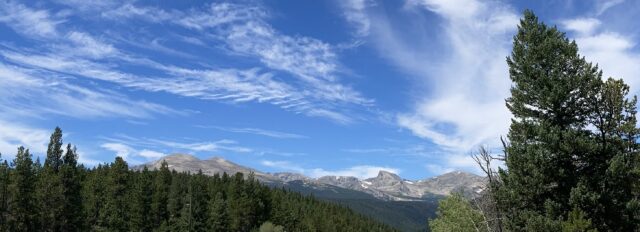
429, 194, 489, 232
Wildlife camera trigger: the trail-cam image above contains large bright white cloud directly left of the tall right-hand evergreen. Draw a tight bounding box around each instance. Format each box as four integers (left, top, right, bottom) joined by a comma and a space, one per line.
375, 0, 518, 153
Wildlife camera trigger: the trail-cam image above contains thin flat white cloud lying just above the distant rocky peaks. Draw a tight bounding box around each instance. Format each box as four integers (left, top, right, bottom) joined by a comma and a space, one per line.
305, 165, 400, 179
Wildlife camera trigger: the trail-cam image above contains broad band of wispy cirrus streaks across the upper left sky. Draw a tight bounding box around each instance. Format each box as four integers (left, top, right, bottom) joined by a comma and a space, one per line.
1, 0, 373, 123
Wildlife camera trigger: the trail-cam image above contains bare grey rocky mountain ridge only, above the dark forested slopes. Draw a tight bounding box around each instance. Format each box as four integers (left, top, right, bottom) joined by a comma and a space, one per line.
133, 154, 485, 201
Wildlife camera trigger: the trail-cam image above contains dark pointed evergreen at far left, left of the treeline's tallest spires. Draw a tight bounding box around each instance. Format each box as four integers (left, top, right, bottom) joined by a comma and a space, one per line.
8, 147, 38, 232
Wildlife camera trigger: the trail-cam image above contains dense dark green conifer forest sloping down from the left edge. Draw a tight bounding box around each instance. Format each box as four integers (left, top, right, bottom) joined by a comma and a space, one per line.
0, 128, 393, 231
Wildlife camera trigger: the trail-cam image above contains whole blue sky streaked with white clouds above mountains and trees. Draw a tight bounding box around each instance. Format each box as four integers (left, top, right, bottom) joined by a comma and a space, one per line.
0, 0, 640, 180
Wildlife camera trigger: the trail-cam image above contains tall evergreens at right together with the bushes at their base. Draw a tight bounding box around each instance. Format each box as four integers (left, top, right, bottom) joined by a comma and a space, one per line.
430, 10, 640, 232
